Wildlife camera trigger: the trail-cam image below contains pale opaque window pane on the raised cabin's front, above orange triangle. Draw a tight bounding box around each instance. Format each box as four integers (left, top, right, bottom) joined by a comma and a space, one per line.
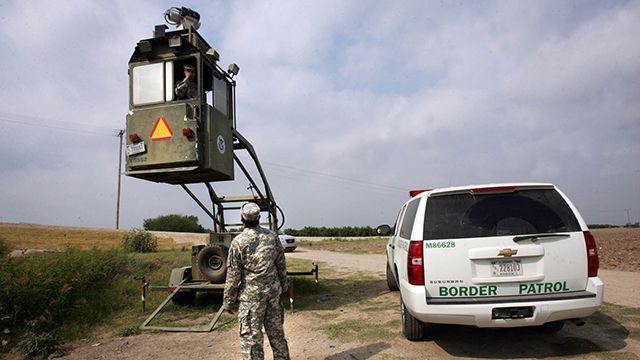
132, 63, 164, 105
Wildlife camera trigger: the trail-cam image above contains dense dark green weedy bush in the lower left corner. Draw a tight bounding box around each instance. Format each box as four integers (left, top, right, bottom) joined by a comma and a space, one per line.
0, 249, 130, 348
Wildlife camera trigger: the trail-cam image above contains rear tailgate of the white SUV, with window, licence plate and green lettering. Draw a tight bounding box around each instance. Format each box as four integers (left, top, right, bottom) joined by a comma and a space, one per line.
423, 185, 587, 303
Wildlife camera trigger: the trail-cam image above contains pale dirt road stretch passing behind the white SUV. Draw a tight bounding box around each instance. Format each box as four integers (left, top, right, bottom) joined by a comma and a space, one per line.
287, 248, 640, 307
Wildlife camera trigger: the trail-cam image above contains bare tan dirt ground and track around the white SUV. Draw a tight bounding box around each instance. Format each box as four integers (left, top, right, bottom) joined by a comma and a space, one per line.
56, 249, 640, 360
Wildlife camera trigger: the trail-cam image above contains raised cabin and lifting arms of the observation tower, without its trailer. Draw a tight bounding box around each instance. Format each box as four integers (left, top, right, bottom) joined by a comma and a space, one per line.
125, 14, 282, 232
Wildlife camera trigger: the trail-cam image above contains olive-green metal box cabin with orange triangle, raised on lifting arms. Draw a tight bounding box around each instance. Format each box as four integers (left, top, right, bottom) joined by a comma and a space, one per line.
125, 25, 235, 184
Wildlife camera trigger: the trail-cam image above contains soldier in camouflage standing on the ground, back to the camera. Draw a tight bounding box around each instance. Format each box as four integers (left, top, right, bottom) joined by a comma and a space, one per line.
222, 203, 290, 360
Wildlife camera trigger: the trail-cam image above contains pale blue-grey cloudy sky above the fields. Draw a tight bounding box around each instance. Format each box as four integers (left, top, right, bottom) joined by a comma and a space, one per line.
0, 0, 640, 228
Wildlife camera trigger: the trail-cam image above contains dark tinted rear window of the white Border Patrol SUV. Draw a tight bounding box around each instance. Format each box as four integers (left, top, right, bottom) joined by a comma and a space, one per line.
424, 189, 580, 240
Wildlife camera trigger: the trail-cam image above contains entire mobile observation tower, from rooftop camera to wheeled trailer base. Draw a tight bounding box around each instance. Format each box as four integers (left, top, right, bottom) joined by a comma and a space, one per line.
125, 7, 318, 332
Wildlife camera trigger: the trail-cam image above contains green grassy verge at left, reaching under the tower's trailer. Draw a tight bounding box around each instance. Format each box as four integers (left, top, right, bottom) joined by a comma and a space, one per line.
0, 249, 323, 358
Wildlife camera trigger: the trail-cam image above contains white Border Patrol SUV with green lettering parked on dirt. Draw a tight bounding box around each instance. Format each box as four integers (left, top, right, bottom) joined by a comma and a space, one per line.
378, 183, 604, 340
